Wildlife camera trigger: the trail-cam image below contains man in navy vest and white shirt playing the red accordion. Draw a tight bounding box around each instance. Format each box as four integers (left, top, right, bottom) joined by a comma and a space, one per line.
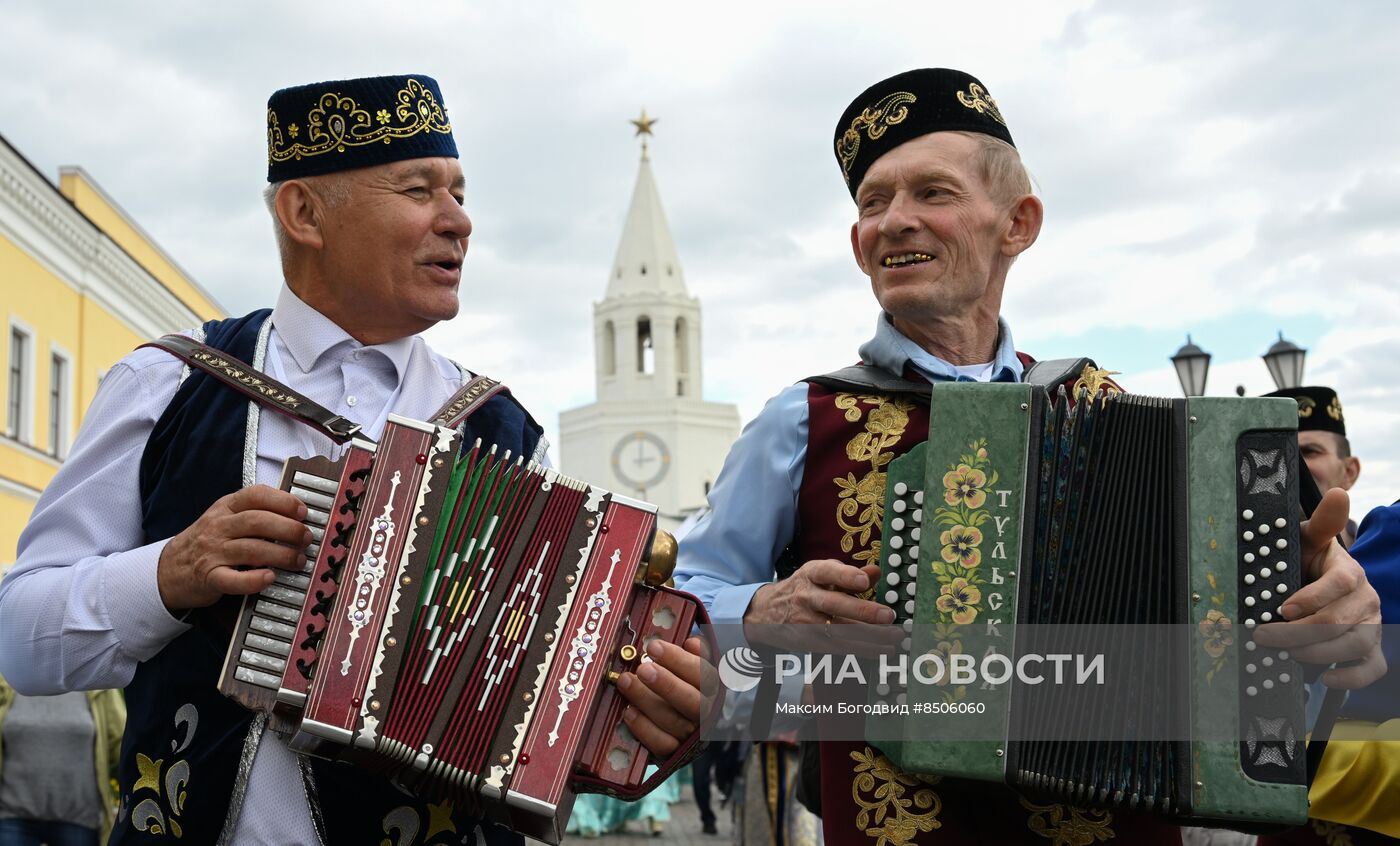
0, 76, 703, 843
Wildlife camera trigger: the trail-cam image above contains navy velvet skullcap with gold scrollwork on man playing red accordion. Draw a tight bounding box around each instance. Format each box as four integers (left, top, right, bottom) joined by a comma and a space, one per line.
267, 76, 458, 182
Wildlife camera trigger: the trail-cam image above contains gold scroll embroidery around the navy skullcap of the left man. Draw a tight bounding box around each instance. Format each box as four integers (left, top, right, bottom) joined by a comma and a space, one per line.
267, 80, 452, 162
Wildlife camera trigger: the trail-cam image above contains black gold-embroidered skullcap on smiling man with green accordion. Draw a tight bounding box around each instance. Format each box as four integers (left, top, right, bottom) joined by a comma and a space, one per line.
836, 67, 1015, 197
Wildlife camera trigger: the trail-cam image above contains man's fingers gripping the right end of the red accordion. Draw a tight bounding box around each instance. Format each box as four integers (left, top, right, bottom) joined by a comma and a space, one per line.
617, 637, 720, 756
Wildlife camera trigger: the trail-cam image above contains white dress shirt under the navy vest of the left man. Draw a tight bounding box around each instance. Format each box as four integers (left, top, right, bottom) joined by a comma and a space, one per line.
0, 286, 476, 843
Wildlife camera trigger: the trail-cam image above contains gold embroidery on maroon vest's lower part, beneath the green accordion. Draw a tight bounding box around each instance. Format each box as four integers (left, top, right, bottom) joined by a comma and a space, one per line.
851, 747, 944, 846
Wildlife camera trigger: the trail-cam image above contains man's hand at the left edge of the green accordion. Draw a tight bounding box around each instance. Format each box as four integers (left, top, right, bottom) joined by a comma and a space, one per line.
743, 559, 902, 656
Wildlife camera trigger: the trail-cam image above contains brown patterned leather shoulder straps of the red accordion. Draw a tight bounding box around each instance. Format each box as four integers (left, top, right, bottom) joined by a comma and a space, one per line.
141, 335, 507, 444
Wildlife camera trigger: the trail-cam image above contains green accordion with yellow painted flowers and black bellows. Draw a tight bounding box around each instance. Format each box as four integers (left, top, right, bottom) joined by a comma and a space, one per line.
867, 382, 1308, 828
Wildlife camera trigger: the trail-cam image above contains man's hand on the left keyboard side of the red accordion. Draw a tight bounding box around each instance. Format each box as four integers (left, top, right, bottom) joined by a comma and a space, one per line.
155, 485, 311, 611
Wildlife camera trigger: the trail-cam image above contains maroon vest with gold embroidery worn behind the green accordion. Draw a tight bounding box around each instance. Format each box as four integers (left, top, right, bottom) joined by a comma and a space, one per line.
788, 382, 1180, 846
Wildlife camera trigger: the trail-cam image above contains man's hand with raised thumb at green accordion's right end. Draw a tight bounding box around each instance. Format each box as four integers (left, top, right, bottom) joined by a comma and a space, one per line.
1256, 487, 1386, 688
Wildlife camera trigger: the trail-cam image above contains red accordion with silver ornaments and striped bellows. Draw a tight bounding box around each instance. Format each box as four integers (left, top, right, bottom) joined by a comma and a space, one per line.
220, 416, 706, 843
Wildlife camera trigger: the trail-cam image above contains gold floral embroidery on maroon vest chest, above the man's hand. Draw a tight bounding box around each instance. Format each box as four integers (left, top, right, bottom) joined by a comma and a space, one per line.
832, 394, 914, 564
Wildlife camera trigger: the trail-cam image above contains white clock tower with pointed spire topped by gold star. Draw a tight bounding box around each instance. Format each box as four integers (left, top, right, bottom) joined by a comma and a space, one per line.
559, 109, 739, 529
